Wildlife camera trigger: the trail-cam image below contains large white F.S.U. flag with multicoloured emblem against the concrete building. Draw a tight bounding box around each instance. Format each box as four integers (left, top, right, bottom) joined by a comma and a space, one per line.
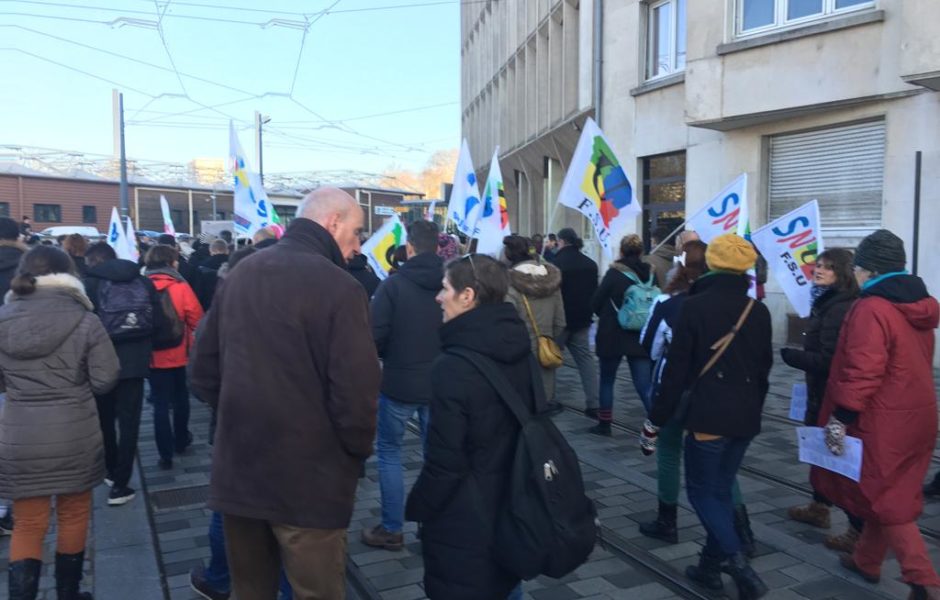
558, 117, 641, 258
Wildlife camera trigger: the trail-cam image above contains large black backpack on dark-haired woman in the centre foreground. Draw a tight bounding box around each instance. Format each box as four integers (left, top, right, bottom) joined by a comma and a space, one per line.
447, 348, 597, 579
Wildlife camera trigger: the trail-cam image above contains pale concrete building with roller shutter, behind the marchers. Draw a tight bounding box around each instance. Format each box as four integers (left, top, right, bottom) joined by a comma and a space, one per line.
461, 0, 940, 356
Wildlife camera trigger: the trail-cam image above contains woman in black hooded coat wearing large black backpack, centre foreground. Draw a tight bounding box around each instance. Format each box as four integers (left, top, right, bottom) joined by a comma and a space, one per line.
405, 254, 535, 600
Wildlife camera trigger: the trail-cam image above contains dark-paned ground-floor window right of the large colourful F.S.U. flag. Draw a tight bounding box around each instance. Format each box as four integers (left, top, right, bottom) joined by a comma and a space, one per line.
643, 152, 685, 248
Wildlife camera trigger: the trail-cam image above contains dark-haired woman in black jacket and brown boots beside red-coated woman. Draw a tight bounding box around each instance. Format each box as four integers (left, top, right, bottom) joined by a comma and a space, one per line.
780, 248, 863, 552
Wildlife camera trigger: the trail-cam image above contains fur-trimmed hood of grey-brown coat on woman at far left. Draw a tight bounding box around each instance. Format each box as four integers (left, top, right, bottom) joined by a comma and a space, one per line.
0, 273, 94, 359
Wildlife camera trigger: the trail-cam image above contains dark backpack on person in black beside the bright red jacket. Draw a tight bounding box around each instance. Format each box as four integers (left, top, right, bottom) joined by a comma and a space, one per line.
98, 277, 154, 342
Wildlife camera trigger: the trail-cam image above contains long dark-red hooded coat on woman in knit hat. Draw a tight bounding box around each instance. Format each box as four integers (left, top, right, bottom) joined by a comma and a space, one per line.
810, 275, 940, 525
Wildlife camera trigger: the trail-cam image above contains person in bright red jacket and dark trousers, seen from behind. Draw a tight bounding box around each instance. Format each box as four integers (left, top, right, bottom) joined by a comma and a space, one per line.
144, 245, 202, 469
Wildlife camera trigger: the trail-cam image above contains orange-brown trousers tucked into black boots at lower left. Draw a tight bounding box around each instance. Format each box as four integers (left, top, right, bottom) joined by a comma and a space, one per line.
10, 490, 91, 562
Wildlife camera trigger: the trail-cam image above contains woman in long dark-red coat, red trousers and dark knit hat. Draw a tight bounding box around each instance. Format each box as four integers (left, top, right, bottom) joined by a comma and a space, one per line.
811, 229, 940, 600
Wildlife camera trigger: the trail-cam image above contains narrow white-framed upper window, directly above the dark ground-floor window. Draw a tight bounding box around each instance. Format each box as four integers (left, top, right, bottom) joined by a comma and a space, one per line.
646, 0, 686, 79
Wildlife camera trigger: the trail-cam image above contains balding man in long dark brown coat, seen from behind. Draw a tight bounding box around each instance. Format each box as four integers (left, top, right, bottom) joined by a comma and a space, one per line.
192, 188, 380, 600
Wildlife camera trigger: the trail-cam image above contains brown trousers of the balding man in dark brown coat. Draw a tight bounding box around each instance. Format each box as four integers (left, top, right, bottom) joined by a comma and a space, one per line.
222, 515, 346, 600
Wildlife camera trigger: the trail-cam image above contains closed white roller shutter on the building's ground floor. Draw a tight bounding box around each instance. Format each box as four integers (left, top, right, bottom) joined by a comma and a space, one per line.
769, 120, 885, 248
